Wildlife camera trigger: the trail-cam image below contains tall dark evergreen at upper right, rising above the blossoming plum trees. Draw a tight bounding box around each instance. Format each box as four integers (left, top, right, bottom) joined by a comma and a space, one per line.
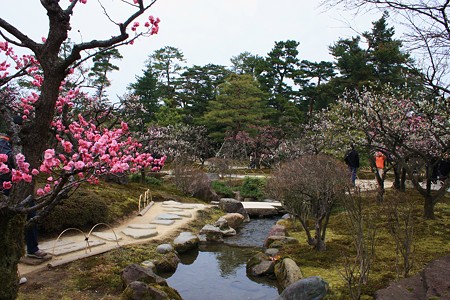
330, 13, 422, 94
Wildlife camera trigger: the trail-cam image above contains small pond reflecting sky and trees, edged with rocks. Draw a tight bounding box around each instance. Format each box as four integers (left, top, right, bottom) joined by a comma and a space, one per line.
166, 218, 279, 300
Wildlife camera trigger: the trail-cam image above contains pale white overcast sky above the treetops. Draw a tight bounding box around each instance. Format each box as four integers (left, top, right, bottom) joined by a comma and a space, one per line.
0, 0, 384, 101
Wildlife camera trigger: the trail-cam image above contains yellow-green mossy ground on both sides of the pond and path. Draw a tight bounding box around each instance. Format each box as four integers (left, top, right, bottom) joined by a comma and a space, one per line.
18, 171, 450, 300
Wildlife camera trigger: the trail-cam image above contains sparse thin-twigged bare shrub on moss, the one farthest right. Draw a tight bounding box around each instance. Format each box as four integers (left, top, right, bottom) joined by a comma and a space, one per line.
383, 191, 415, 277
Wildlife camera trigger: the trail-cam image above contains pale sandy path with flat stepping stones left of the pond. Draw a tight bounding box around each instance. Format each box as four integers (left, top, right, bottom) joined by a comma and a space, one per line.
19, 201, 206, 276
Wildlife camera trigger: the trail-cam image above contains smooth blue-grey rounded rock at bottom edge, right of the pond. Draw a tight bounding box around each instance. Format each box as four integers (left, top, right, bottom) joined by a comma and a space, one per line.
277, 276, 328, 300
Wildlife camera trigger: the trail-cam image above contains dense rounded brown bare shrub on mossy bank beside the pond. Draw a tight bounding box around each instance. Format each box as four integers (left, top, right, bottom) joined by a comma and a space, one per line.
267, 155, 350, 251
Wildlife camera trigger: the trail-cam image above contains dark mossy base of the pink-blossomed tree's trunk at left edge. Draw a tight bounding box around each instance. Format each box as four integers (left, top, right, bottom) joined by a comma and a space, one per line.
0, 209, 25, 300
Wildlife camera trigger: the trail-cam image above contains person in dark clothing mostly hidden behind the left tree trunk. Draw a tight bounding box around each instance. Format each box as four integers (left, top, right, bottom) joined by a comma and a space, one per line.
0, 133, 47, 259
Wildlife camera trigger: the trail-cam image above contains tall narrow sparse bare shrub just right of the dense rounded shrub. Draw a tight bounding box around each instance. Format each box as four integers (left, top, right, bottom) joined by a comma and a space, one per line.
342, 189, 376, 299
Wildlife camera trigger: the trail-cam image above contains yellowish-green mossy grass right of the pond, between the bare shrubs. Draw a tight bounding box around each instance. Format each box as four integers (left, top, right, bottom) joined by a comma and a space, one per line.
281, 191, 450, 299
